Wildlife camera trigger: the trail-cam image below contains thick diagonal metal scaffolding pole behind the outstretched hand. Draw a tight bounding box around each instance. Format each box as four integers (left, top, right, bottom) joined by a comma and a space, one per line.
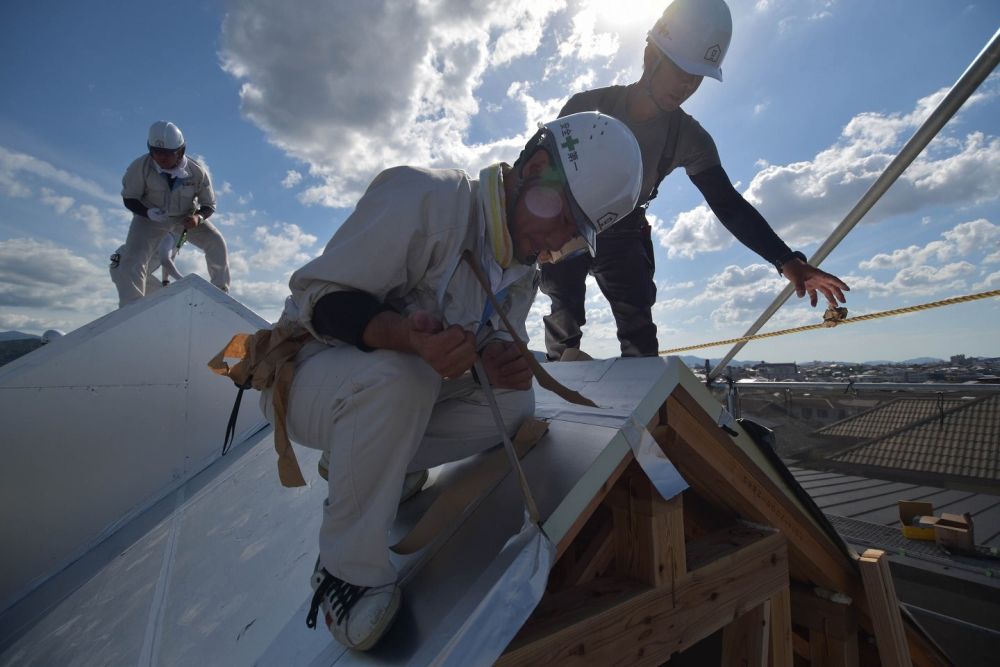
709, 30, 1000, 379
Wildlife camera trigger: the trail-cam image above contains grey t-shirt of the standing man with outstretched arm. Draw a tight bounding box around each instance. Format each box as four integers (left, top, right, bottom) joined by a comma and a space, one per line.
559, 86, 721, 206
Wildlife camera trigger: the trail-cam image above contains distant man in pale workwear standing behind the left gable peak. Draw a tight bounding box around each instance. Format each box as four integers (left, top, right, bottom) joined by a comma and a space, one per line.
112, 120, 229, 307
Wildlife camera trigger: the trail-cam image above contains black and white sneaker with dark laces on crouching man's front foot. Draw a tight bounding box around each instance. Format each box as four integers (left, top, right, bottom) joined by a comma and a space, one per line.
306, 559, 402, 651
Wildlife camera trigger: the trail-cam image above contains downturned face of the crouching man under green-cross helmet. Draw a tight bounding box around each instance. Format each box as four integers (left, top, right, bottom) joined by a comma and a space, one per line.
509, 150, 580, 264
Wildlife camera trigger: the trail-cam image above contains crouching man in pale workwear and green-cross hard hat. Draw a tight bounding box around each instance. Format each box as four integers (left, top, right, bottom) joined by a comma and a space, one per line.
261, 112, 642, 650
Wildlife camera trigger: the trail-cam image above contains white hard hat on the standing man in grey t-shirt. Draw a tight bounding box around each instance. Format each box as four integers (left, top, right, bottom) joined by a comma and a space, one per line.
649, 0, 733, 81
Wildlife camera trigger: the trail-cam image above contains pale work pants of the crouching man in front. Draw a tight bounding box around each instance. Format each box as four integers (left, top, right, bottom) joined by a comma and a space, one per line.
261, 344, 535, 586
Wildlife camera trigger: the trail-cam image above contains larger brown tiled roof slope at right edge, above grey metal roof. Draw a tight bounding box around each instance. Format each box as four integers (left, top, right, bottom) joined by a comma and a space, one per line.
832, 394, 1000, 481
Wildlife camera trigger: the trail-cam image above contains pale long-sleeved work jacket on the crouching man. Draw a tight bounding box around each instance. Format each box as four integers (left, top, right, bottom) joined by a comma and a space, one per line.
282, 167, 538, 349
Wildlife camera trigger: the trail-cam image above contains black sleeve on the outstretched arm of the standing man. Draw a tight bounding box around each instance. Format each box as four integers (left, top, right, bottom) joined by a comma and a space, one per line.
690, 165, 792, 264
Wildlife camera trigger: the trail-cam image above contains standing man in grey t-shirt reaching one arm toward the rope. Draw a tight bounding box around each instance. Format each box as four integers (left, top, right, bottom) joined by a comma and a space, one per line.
541, 0, 848, 360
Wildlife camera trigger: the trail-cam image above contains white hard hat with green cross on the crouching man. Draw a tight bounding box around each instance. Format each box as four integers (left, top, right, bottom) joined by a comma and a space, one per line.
541, 111, 642, 255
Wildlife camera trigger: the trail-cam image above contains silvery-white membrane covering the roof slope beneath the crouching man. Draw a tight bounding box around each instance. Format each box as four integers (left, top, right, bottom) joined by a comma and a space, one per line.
0, 330, 692, 666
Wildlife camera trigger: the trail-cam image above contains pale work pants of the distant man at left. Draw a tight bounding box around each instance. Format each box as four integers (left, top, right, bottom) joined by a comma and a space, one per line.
115, 215, 229, 308
